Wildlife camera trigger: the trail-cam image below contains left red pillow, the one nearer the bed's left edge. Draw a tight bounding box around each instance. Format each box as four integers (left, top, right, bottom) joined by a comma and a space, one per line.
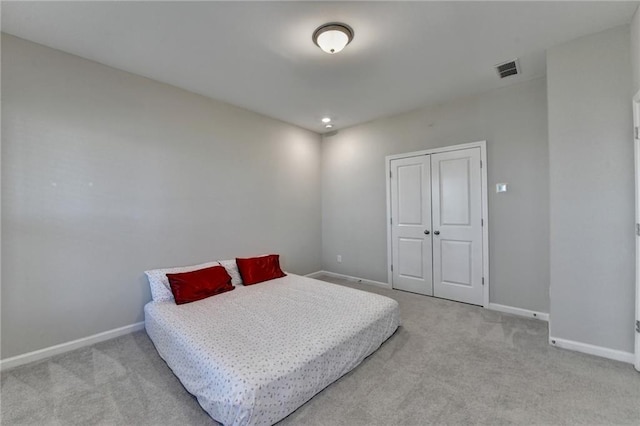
167, 265, 235, 305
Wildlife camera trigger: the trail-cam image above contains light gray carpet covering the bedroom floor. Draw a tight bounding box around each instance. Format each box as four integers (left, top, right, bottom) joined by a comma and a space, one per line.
1, 277, 640, 425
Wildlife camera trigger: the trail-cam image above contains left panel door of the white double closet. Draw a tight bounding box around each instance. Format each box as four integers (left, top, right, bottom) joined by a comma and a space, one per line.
391, 155, 433, 296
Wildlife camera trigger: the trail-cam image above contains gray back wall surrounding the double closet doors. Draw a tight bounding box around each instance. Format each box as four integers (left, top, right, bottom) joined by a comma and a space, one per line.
322, 79, 549, 312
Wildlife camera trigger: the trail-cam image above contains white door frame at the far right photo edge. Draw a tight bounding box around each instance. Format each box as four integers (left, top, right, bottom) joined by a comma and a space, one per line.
632, 90, 640, 371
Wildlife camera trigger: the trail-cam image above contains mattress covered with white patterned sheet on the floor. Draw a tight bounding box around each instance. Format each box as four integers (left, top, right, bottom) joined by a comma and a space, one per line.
145, 274, 400, 425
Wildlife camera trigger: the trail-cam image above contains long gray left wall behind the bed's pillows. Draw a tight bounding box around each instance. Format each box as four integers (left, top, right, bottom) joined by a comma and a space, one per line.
1, 35, 321, 358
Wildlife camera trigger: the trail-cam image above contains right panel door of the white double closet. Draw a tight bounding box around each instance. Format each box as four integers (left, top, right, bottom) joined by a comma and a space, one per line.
431, 148, 483, 305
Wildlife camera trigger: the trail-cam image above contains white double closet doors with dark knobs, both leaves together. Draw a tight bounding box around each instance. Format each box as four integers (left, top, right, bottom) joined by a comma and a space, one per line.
390, 147, 484, 305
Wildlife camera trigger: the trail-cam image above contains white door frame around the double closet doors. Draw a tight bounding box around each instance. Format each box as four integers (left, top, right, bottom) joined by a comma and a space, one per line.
385, 141, 491, 308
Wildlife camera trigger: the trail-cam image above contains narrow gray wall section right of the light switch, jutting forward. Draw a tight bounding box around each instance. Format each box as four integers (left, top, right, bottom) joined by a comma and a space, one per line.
547, 26, 635, 352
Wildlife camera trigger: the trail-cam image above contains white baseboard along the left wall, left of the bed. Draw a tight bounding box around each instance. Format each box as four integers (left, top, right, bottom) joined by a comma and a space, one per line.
0, 322, 144, 371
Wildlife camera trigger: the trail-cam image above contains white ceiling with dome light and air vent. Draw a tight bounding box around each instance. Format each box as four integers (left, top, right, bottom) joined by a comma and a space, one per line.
2, 1, 638, 132
